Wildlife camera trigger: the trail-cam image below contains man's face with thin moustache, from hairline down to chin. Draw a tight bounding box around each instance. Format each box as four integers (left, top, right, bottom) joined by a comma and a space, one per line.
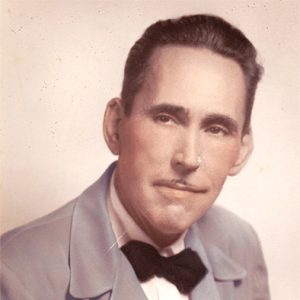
106, 46, 250, 244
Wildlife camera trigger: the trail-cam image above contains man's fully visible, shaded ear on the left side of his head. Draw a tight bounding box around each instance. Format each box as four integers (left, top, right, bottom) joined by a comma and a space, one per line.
103, 98, 124, 155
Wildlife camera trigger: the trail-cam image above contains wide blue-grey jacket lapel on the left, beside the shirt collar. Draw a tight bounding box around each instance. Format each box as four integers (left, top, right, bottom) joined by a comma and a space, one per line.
70, 165, 120, 299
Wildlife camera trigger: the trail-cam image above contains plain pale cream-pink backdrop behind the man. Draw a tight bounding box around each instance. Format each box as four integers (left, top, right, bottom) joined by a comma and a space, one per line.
0, 0, 300, 300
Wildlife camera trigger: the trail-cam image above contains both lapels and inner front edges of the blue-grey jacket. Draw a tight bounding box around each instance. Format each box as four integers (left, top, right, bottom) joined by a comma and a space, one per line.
70, 163, 246, 300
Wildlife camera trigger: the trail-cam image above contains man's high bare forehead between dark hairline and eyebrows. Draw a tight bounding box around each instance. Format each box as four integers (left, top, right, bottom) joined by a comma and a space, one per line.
134, 45, 246, 120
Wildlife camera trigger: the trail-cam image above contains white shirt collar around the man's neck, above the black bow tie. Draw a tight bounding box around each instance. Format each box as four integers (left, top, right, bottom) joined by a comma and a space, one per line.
107, 172, 186, 256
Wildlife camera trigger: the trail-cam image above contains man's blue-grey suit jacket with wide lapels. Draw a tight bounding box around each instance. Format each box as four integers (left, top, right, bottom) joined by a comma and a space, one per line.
1, 165, 269, 300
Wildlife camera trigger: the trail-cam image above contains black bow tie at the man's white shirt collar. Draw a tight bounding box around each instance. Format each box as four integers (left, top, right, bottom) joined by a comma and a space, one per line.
121, 241, 207, 294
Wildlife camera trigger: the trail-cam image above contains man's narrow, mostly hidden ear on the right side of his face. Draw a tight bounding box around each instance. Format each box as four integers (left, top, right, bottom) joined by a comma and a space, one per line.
229, 129, 253, 176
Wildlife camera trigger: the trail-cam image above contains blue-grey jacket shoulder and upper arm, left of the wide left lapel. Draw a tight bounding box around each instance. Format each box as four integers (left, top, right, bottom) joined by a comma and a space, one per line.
1, 200, 76, 299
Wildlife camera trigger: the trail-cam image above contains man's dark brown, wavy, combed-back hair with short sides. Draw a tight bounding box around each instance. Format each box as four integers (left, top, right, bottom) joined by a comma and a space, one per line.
121, 15, 263, 131
